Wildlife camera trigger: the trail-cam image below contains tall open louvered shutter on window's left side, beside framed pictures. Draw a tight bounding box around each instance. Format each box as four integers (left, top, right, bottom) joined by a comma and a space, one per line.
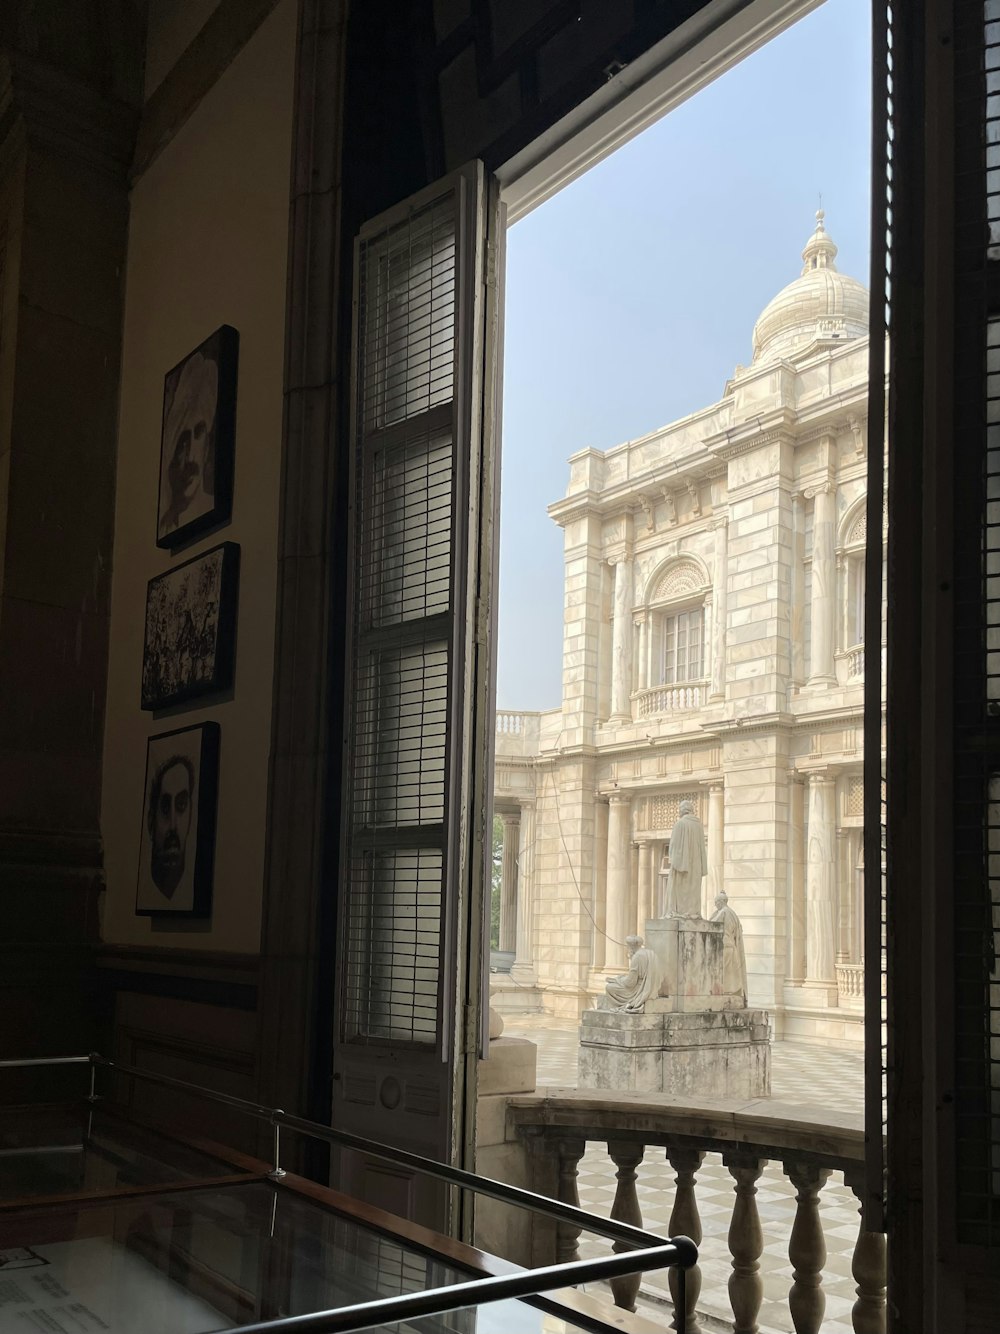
333, 164, 499, 1227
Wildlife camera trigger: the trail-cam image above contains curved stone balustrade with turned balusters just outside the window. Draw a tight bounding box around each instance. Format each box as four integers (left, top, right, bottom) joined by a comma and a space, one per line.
507, 1090, 885, 1334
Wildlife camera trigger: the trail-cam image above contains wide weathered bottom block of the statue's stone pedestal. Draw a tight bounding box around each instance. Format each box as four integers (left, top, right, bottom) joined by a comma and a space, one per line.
577, 998, 771, 1098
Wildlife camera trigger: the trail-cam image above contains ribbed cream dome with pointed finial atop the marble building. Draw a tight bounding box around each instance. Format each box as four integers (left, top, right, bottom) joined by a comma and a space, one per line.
753, 209, 868, 366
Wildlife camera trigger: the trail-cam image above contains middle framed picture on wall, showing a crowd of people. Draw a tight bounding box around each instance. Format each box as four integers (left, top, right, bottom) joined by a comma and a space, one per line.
141, 542, 240, 708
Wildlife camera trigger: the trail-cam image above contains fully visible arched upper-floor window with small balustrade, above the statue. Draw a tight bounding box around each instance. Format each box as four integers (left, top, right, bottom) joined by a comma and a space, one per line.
640, 556, 711, 714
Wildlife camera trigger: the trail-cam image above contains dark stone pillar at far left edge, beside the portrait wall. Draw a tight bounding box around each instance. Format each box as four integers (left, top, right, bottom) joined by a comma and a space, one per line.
0, 13, 141, 1099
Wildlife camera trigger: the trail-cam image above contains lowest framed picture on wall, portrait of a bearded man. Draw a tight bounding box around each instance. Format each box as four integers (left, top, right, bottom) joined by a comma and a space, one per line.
136, 723, 219, 918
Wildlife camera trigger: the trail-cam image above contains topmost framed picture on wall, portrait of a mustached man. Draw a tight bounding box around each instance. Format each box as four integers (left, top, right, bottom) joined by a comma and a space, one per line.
156, 324, 240, 547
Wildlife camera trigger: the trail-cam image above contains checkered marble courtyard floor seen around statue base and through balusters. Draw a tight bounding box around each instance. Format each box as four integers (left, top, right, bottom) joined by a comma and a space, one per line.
504, 1015, 864, 1334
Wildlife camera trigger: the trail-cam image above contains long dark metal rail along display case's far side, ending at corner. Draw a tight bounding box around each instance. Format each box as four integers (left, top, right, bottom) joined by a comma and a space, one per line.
0, 1051, 693, 1248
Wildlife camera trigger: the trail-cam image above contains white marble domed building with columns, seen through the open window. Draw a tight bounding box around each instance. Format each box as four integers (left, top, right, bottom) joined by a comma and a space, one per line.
493, 213, 881, 1043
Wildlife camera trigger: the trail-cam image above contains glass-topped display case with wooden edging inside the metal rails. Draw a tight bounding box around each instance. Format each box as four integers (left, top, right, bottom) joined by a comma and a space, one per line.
0, 1103, 674, 1334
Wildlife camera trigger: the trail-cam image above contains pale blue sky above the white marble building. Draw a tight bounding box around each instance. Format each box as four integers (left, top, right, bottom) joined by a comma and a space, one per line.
497, 0, 871, 708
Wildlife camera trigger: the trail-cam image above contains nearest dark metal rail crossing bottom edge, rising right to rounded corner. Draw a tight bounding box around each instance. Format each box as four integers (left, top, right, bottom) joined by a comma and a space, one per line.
204, 1237, 697, 1334
